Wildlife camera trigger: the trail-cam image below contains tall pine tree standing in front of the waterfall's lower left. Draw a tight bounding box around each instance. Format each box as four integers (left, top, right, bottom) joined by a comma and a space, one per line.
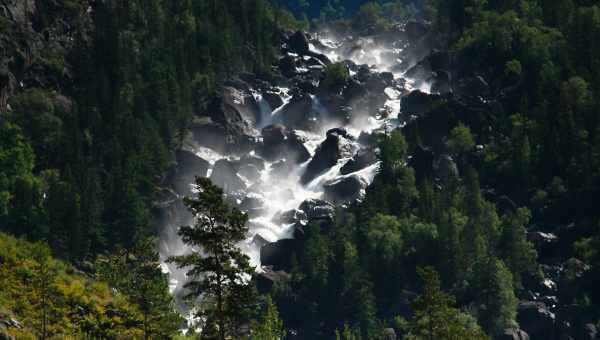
169, 178, 254, 340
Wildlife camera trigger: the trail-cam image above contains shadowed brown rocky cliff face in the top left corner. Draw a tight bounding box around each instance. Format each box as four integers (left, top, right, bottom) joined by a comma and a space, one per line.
0, 0, 92, 111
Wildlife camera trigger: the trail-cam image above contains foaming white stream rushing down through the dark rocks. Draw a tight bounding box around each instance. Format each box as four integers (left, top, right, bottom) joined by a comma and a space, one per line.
160, 25, 428, 316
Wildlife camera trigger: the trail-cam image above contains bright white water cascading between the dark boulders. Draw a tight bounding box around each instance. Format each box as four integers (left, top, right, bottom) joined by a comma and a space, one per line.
160, 27, 428, 318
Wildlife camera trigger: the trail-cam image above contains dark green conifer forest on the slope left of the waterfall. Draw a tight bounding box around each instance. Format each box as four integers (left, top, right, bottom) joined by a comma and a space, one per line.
0, 0, 282, 261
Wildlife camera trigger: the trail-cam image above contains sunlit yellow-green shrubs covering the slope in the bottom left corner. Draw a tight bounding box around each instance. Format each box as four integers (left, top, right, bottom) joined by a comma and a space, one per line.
0, 233, 146, 339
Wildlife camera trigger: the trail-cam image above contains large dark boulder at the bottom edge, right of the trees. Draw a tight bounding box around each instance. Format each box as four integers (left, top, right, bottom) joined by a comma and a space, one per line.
518, 301, 556, 339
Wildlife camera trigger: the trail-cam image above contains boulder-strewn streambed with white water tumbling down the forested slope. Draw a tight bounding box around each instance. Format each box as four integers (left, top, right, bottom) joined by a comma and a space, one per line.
157, 21, 429, 300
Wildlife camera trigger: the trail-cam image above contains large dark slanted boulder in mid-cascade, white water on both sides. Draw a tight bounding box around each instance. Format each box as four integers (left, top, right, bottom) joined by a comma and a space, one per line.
300, 129, 353, 184
